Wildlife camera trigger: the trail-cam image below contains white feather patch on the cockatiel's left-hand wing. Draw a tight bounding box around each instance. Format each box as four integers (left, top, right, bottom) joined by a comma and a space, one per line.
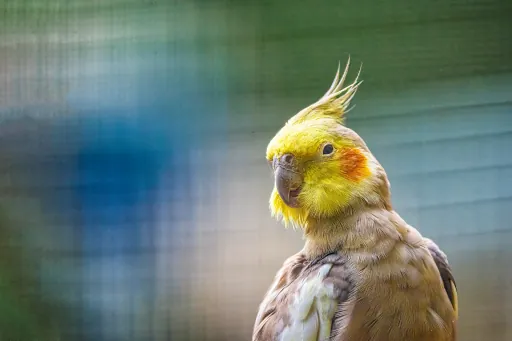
279, 264, 338, 341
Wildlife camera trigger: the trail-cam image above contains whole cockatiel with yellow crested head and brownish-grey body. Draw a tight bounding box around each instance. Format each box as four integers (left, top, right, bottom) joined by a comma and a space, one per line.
252, 59, 458, 341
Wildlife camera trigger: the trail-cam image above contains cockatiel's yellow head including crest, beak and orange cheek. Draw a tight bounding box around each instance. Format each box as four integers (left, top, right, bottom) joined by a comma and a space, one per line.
266, 60, 389, 227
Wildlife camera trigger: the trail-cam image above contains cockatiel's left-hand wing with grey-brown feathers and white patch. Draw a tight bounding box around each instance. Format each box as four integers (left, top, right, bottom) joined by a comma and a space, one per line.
252, 253, 354, 341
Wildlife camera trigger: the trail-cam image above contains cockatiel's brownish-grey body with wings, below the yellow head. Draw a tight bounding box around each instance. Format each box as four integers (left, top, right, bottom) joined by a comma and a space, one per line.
253, 211, 457, 341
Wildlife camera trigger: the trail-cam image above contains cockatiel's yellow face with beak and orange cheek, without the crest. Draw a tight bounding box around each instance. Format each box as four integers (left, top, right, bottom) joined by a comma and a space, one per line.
266, 118, 372, 226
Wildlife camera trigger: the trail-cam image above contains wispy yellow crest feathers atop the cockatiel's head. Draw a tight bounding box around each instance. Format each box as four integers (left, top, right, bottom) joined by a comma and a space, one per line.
287, 57, 363, 124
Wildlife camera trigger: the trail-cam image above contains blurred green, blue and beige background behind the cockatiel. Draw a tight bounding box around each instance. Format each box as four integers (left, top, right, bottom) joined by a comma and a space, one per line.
0, 0, 512, 341
